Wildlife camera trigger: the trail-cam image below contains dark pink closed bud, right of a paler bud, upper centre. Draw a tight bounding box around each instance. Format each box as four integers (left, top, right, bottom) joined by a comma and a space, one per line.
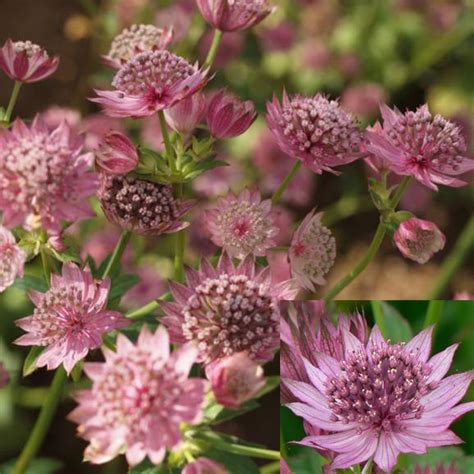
206, 89, 257, 138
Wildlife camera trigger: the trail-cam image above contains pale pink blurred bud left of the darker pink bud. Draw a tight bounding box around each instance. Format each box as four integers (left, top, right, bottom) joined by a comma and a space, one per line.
165, 92, 206, 135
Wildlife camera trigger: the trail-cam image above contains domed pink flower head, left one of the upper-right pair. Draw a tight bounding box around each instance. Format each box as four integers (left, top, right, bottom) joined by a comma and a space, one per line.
267, 92, 362, 174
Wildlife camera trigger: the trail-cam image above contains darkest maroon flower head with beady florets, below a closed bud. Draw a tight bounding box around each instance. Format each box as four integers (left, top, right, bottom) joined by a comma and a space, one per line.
97, 173, 193, 235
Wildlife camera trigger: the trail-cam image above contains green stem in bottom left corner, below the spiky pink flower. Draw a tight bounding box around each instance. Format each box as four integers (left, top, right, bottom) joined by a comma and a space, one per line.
12, 366, 67, 474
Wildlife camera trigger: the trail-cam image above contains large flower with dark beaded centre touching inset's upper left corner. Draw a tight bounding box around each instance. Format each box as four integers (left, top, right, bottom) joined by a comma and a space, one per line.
161, 253, 296, 365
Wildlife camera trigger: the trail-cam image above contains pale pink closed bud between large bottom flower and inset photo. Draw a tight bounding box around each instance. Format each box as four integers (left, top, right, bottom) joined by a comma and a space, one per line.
206, 352, 265, 408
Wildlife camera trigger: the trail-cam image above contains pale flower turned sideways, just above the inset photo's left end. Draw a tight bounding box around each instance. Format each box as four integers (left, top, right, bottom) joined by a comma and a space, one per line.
289, 211, 336, 291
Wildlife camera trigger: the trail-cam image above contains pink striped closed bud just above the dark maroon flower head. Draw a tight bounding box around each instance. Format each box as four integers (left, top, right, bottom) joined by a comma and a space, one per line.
95, 131, 139, 174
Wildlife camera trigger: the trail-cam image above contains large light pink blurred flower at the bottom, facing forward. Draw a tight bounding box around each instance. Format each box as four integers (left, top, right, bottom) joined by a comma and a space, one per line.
69, 326, 206, 466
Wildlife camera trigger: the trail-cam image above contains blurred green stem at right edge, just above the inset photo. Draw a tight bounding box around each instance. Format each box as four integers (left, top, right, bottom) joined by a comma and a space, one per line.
427, 215, 474, 300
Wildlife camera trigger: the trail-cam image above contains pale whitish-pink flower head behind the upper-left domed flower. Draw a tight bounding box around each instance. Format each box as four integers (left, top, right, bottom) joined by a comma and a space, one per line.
103, 24, 173, 69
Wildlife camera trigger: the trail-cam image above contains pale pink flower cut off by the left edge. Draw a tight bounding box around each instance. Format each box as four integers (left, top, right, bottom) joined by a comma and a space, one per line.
0, 225, 26, 293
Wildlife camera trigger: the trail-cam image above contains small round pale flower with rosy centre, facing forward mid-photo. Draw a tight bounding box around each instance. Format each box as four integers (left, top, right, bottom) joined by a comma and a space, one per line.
206, 189, 278, 258
